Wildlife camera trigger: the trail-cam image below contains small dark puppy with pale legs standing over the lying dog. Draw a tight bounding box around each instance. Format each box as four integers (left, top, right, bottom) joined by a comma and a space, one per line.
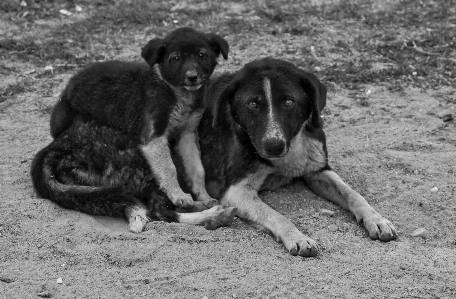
47, 28, 229, 213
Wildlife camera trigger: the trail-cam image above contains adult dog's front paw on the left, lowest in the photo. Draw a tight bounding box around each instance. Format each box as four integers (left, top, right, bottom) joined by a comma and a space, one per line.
278, 229, 318, 257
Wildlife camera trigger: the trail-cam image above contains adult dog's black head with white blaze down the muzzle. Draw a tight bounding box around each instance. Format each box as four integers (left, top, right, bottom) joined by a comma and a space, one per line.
206, 58, 326, 159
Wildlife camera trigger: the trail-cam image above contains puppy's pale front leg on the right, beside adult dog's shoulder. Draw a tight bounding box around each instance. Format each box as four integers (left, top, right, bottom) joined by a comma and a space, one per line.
176, 131, 218, 208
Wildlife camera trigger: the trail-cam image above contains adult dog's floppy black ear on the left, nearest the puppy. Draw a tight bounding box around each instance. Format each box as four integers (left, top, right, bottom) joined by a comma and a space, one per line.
204, 74, 239, 129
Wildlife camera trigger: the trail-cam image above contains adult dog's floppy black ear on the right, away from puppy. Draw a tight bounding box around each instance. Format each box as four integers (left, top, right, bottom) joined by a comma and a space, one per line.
298, 70, 326, 129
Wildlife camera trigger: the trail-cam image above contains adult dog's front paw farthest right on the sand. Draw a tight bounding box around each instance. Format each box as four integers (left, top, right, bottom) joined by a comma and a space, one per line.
361, 211, 397, 242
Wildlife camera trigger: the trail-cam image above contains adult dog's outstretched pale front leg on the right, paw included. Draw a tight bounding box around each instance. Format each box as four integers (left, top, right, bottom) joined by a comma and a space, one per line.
304, 170, 397, 242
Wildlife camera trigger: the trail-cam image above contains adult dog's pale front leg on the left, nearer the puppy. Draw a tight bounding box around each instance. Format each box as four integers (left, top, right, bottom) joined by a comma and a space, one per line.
221, 169, 318, 256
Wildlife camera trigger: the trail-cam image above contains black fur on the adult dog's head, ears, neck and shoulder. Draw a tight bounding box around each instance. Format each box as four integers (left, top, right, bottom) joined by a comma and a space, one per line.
198, 58, 329, 198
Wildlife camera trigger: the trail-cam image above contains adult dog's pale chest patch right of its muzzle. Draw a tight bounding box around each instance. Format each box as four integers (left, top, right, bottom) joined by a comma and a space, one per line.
271, 132, 327, 177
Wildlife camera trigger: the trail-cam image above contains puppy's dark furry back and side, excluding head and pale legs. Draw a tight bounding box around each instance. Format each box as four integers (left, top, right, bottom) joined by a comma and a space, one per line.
51, 61, 176, 138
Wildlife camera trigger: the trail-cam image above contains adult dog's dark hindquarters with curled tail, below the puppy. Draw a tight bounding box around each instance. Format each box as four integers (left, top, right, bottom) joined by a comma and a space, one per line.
31, 115, 177, 222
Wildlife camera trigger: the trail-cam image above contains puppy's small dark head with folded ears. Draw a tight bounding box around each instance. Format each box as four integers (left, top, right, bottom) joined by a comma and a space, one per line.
141, 28, 229, 90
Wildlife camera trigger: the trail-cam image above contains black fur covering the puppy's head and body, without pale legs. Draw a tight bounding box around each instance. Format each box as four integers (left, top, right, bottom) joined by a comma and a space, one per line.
50, 28, 229, 142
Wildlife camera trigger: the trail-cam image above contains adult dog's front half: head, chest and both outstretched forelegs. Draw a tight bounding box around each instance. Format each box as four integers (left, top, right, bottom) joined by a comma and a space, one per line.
198, 58, 397, 256
